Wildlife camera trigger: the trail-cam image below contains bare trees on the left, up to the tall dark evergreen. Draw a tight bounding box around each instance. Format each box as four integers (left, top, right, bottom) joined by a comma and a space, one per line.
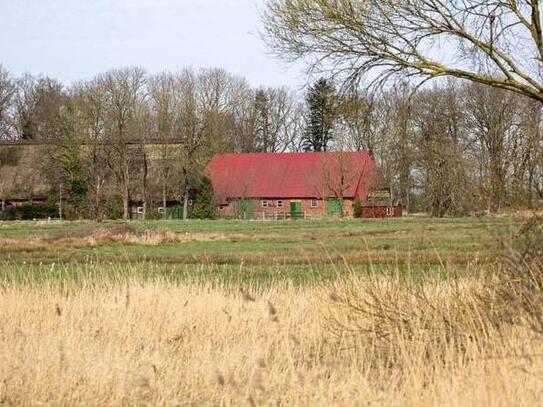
0, 68, 302, 219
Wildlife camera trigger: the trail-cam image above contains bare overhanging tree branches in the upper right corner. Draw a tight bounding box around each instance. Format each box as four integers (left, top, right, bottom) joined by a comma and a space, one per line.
264, 0, 543, 101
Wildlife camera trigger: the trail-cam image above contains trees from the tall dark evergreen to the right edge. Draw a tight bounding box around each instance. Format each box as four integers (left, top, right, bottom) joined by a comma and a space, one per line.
302, 79, 543, 216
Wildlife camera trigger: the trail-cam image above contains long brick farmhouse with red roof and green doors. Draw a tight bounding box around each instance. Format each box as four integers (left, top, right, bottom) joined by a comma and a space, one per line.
206, 152, 401, 219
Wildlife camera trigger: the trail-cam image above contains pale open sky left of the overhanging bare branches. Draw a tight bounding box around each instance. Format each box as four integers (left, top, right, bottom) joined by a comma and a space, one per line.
0, 0, 305, 88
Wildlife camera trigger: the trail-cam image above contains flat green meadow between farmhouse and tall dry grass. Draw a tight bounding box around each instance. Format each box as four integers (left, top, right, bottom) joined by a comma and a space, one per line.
0, 217, 522, 284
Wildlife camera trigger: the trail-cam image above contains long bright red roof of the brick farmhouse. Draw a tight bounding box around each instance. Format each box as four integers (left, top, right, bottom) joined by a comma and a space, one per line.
205, 152, 376, 200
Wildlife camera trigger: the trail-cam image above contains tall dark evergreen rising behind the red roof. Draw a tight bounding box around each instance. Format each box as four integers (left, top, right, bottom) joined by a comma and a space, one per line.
303, 78, 336, 151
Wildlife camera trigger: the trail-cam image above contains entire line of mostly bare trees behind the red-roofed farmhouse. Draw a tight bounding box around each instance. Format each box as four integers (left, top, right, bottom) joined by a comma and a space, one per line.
0, 63, 543, 220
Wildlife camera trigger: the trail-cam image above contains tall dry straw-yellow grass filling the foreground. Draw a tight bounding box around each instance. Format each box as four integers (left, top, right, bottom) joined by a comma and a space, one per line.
0, 276, 543, 406
